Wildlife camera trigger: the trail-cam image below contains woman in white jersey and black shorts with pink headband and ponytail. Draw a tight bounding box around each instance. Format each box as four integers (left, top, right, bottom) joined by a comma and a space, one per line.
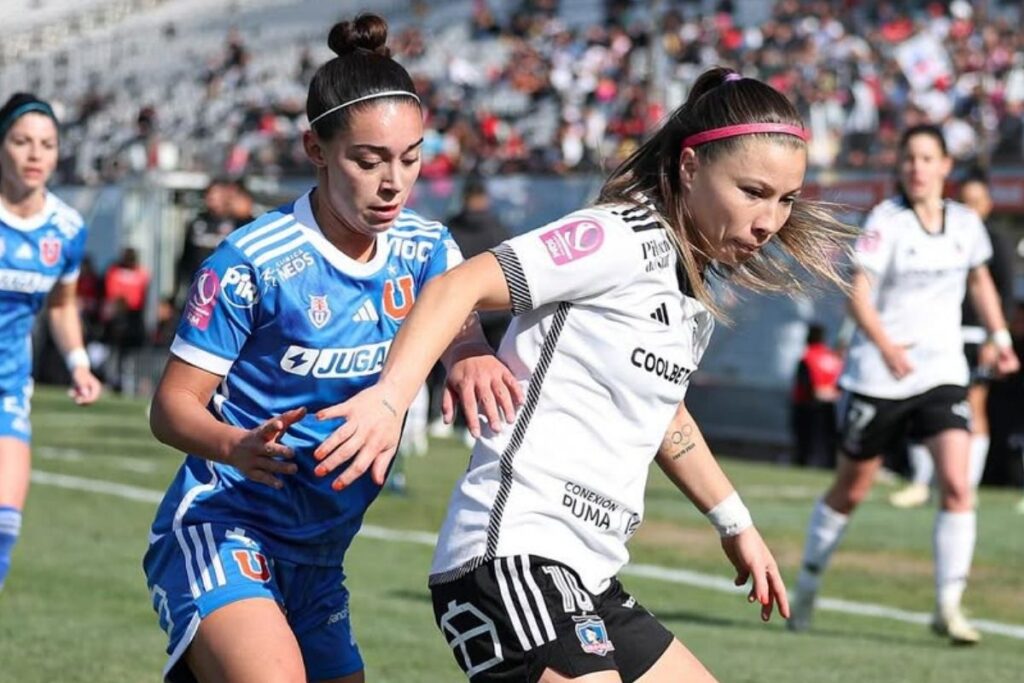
316, 69, 846, 683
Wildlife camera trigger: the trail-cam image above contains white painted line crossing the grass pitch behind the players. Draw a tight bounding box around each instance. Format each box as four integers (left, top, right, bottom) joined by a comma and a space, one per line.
32, 469, 1024, 640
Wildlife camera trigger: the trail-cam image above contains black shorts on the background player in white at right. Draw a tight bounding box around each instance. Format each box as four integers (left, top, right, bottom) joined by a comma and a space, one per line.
838, 384, 971, 460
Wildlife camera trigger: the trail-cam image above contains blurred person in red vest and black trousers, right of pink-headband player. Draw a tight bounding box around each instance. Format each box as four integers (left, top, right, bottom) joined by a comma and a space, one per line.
791, 323, 843, 467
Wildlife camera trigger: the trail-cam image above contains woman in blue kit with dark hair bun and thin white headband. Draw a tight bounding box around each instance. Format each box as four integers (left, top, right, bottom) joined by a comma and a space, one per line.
144, 14, 519, 683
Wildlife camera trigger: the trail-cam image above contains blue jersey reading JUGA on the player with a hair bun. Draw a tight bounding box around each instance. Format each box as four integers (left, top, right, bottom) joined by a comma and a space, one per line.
153, 194, 462, 566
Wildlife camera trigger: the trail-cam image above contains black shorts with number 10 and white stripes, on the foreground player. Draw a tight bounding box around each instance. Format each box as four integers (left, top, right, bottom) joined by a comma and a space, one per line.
430, 555, 674, 683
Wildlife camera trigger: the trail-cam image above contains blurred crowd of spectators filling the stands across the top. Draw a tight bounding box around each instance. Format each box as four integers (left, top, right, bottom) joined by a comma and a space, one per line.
14, 0, 1024, 182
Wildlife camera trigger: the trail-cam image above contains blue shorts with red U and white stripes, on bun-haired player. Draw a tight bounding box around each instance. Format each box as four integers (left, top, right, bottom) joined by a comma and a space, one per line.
142, 523, 364, 682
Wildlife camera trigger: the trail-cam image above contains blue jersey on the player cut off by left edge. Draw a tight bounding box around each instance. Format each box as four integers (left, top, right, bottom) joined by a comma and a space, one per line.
0, 194, 86, 395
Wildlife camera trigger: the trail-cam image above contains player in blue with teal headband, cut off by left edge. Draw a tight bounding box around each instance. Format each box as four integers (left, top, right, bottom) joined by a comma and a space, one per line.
0, 93, 100, 589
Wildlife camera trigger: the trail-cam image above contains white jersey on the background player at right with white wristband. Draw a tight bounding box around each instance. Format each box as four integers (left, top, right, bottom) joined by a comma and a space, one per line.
840, 198, 992, 398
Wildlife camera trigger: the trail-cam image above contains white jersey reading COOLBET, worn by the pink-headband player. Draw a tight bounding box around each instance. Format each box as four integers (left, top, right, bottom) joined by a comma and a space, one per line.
431, 198, 713, 593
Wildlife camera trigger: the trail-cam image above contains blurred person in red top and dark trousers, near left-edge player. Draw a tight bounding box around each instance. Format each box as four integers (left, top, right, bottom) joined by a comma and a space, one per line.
103, 247, 150, 395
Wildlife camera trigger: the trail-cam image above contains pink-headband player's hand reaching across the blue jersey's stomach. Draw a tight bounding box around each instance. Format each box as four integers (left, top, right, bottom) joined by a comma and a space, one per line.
313, 384, 408, 490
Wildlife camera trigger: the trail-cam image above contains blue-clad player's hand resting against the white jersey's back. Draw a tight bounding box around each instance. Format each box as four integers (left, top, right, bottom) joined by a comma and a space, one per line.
441, 345, 524, 438
